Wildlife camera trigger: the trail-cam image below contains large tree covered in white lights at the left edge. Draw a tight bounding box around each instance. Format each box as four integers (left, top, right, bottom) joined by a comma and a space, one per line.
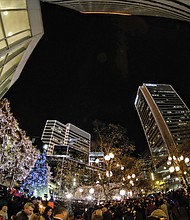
0, 98, 40, 186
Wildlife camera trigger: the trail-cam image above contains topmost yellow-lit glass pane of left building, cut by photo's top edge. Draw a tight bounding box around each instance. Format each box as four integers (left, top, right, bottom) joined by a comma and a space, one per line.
0, 0, 26, 9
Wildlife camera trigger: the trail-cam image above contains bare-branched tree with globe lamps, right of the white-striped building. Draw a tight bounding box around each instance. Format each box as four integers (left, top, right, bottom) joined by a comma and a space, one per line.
92, 121, 140, 200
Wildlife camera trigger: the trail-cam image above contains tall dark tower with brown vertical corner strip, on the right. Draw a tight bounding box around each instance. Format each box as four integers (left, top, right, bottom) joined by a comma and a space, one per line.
135, 84, 190, 167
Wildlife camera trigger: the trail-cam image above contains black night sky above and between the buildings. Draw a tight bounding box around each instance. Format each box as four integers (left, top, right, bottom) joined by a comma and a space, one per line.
5, 3, 190, 152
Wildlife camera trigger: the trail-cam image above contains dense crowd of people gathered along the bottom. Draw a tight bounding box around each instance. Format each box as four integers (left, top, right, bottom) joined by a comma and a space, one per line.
0, 186, 190, 220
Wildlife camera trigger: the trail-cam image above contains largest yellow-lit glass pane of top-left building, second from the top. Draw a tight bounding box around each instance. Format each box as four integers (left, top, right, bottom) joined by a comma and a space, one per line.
1, 10, 30, 37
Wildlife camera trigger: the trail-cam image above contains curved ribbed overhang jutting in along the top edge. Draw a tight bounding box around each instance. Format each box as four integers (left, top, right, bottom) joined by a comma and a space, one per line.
41, 0, 190, 22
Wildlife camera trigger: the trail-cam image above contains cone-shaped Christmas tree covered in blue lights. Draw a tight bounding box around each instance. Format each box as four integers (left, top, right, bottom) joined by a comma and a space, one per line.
21, 150, 51, 197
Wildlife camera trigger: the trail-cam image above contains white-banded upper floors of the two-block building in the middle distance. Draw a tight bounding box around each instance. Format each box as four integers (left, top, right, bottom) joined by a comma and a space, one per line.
41, 120, 91, 156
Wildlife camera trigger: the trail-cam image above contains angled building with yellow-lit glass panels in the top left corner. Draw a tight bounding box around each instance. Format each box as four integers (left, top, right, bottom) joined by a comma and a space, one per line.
0, 0, 44, 98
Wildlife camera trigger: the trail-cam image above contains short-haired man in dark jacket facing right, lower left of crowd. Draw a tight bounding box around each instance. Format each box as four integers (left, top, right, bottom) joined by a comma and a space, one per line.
15, 202, 35, 220
